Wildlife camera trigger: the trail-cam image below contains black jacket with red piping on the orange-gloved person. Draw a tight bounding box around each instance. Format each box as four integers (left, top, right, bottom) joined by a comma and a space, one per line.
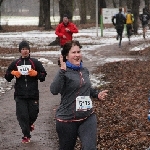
5, 56, 47, 100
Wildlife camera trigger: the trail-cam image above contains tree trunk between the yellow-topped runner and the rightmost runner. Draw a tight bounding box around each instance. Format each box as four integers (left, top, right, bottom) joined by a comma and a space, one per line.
132, 0, 140, 34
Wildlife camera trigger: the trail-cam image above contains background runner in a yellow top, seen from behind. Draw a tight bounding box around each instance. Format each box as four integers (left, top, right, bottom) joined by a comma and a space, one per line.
126, 9, 134, 41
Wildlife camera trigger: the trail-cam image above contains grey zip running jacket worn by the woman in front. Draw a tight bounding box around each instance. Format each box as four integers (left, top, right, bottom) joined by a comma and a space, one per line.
50, 67, 99, 121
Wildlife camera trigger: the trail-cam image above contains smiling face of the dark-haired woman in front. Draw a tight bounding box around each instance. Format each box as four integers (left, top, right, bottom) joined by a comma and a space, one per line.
66, 45, 82, 66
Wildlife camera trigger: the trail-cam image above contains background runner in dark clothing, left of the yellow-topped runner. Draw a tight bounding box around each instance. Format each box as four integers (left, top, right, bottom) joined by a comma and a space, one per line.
112, 8, 126, 47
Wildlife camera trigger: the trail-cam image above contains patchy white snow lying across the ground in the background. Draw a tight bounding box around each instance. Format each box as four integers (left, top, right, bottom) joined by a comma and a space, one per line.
0, 18, 150, 94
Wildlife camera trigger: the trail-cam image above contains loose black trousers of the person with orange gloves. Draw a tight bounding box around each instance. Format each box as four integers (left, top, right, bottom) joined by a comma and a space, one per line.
15, 98, 39, 138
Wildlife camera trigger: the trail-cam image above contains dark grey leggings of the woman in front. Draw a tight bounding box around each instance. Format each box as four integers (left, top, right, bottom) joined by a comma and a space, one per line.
56, 114, 97, 150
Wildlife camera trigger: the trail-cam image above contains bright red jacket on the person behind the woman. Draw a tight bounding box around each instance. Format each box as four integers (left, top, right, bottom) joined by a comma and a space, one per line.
55, 22, 78, 46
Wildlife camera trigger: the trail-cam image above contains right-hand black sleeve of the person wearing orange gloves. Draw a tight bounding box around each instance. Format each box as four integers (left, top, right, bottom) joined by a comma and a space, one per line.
36, 61, 47, 82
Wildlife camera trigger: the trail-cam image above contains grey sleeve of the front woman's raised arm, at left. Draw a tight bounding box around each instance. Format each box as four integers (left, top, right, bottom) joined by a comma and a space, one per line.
50, 69, 66, 95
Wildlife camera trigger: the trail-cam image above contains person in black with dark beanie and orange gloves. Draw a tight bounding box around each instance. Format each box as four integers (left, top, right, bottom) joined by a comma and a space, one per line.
5, 41, 47, 143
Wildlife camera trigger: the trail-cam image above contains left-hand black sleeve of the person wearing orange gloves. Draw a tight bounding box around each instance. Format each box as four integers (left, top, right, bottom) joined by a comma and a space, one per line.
5, 61, 15, 82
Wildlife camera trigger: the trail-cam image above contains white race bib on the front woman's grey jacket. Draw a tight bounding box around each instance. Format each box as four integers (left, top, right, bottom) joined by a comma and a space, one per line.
76, 96, 92, 111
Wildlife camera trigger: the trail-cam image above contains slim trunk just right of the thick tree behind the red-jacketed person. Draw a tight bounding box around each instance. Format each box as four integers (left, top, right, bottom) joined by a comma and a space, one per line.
79, 0, 87, 24
